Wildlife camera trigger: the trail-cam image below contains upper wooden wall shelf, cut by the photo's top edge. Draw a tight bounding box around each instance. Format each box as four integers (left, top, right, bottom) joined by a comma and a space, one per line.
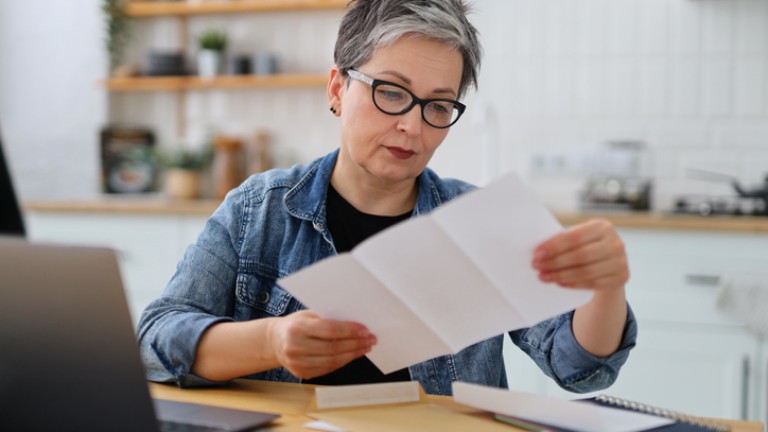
125, 0, 347, 18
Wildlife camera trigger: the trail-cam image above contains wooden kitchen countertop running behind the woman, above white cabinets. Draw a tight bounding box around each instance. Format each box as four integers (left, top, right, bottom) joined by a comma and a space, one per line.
24, 196, 768, 233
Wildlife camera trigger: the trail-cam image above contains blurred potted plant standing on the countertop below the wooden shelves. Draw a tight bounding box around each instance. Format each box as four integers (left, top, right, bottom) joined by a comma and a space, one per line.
159, 146, 213, 199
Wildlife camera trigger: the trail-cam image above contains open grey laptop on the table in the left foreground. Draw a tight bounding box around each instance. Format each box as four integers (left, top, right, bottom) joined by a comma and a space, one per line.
0, 236, 279, 432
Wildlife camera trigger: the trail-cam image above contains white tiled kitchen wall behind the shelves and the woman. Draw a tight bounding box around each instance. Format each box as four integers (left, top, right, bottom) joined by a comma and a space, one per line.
0, 0, 768, 210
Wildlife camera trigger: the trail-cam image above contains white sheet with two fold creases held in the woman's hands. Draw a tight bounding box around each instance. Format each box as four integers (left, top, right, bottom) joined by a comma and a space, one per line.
278, 174, 591, 373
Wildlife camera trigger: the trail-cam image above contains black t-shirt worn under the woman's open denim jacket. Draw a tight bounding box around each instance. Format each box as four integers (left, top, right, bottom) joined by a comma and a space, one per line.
304, 184, 411, 385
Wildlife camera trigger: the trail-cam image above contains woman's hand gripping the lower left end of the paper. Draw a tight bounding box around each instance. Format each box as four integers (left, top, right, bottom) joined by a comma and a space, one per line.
269, 310, 376, 379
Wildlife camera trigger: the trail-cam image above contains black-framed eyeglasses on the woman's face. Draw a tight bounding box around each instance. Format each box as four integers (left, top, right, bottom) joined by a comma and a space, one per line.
347, 69, 467, 129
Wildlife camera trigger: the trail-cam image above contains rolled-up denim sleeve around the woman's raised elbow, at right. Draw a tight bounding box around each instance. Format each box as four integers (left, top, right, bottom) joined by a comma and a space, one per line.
509, 305, 637, 393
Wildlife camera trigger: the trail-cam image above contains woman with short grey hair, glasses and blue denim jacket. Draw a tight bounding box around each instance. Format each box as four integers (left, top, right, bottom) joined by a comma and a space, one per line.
139, 0, 636, 394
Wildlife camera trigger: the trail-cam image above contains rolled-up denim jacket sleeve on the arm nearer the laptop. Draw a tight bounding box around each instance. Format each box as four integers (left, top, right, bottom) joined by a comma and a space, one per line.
138, 192, 244, 387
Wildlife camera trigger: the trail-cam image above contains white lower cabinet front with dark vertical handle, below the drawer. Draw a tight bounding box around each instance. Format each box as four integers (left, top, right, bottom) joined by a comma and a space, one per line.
506, 321, 761, 418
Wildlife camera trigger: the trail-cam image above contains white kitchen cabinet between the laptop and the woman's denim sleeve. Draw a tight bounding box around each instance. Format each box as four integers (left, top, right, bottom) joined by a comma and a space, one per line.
25, 212, 207, 322
